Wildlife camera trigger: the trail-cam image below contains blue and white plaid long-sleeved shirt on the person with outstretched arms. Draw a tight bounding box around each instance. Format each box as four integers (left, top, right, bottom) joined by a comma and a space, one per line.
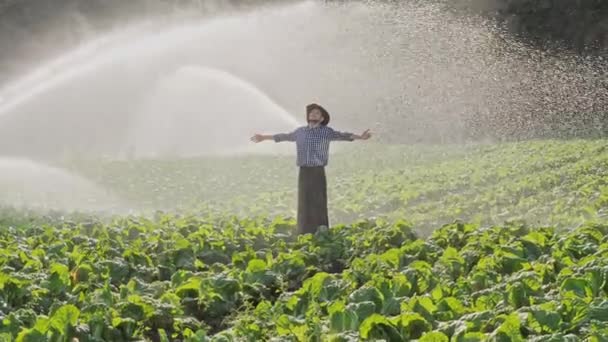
273, 126, 354, 167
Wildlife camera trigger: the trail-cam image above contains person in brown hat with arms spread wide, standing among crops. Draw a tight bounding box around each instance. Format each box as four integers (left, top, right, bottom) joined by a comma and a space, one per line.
251, 103, 371, 234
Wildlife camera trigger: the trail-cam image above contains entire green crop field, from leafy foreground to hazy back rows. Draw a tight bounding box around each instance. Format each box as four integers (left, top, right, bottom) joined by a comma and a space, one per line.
0, 139, 608, 342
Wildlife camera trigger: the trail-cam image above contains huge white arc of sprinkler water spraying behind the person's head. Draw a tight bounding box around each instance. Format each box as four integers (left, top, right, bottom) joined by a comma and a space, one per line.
0, 1, 608, 211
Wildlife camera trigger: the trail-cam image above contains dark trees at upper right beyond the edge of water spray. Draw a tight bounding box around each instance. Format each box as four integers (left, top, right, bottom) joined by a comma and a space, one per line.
458, 0, 608, 139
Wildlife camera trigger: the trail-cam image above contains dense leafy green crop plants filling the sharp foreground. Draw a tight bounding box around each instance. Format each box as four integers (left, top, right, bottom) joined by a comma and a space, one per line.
0, 216, 608, 341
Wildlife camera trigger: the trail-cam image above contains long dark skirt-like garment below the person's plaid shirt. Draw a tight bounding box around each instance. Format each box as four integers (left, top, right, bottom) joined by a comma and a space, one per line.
298, 166, 329, 234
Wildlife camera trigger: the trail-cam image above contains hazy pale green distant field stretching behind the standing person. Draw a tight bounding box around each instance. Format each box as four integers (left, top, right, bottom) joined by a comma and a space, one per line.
69, 140, 608, 229
